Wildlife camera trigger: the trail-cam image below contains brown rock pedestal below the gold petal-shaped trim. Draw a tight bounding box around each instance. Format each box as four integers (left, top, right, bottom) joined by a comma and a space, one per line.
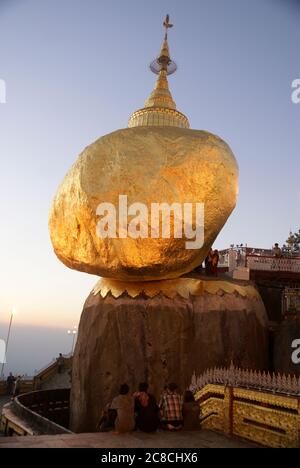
71, 291, 268, 432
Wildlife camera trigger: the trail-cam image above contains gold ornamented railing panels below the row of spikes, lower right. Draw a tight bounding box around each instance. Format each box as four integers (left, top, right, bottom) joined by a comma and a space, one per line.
196, 385, 300, 448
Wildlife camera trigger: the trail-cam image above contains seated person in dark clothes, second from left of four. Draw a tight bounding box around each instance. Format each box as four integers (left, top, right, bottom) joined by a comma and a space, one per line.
133, 382, 159, 432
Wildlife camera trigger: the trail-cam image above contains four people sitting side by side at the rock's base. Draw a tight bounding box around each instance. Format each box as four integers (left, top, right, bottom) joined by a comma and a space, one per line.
99, 382, 200, 434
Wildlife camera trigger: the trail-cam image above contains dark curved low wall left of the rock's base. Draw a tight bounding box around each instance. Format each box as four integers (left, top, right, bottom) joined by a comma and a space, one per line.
1, 389, 71, 435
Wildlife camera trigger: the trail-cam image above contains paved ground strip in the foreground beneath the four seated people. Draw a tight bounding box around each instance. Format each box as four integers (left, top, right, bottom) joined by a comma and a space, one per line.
0, 430, 258, 449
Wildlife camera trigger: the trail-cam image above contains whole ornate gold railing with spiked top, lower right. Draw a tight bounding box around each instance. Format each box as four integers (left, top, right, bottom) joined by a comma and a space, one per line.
190, 366, 300, 447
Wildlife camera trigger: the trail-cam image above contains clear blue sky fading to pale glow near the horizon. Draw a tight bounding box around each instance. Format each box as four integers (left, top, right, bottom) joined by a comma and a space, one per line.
0, 0, 300, 370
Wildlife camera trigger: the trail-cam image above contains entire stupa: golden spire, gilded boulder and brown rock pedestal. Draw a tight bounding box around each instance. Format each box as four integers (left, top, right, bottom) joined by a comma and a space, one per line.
49, 16, 268, 432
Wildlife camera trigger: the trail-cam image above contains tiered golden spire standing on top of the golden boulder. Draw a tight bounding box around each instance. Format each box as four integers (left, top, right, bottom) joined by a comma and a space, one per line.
128, 15, 189, 128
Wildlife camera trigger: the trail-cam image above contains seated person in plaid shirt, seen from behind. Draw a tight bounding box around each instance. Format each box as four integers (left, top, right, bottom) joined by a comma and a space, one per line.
159, 383, 182, 430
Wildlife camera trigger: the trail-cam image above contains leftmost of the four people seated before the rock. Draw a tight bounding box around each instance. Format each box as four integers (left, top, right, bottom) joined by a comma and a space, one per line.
110, 383, 135, 434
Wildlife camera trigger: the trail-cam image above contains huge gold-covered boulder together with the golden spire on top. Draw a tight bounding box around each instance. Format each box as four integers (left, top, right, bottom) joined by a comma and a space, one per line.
49, 17, 238, 281
